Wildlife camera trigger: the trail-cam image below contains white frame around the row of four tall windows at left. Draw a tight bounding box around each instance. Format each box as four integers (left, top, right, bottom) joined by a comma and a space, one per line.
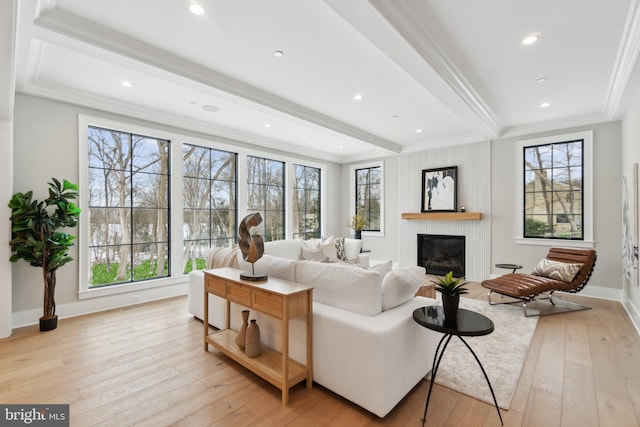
77, 114, 327, 303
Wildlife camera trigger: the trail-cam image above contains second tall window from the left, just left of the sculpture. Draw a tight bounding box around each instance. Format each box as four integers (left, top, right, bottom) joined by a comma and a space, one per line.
182, 144, 238, 274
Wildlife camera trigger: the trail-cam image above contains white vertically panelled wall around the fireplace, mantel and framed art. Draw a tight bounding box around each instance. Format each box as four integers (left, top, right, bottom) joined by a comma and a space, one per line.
342, 142, 491, 280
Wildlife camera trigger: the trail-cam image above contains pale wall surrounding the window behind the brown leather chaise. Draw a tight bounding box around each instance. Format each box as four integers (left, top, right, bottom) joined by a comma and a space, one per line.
491, 122, 622, 299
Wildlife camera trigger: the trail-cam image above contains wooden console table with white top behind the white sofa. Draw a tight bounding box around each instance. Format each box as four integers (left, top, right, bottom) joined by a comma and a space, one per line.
204, 268, 313, 405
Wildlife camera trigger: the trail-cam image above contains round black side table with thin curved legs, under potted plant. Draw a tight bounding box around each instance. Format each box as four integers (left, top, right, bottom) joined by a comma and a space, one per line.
413, 306, 504, 427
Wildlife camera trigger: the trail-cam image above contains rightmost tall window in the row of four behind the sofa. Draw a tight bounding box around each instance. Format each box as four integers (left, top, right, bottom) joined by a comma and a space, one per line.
292, 164, 321, 239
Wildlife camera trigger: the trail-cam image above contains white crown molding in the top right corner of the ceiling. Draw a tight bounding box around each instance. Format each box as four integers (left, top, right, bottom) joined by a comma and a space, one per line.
603, 0, 640, 120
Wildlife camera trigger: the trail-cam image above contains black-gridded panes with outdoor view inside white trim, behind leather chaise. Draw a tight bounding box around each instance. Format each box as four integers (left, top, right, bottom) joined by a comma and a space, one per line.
523, 140, 584, 240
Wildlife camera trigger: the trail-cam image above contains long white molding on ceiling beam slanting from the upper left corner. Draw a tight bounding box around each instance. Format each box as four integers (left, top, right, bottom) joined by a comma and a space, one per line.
35, 9, 401, 153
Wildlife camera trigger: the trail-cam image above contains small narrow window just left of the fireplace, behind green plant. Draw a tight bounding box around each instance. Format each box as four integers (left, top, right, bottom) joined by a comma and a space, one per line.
352, 163, 382, 232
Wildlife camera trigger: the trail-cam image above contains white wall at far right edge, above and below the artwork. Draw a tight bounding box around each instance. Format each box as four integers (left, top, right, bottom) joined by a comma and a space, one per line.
620, 70, 640, 330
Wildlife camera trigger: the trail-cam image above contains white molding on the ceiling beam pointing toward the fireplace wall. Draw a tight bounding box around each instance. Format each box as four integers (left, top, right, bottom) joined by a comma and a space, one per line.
369, 0, 503, 139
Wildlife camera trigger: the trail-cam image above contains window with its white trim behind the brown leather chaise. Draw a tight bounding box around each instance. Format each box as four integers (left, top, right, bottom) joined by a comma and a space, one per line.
518, 132, 592, 243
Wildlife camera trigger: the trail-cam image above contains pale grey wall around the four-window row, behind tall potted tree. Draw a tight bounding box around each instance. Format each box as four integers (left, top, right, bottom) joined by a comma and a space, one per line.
11, 95, 340, 328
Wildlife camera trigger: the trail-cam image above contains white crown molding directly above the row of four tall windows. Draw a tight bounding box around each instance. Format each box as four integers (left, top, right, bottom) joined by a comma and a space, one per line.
20, 83, 343, 163
